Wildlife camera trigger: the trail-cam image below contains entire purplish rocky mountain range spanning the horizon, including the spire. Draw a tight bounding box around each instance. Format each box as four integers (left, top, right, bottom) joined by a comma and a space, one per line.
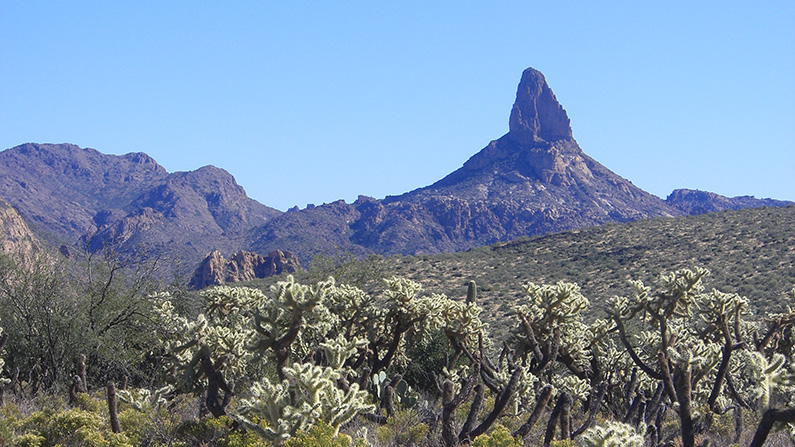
0, 68, 792, 265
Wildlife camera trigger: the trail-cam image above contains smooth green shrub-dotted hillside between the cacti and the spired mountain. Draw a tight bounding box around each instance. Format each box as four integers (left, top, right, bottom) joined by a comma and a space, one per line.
300, 206, 795, 338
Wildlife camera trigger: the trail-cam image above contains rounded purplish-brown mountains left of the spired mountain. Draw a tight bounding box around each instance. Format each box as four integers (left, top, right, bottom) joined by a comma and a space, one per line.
0, 144, 280, 265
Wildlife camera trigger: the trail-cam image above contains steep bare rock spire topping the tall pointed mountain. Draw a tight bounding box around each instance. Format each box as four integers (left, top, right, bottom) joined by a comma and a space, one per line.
509, 68, 572, 143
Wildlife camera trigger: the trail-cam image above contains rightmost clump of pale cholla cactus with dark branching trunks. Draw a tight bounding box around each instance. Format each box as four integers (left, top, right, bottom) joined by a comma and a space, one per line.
610, 269, 795, 447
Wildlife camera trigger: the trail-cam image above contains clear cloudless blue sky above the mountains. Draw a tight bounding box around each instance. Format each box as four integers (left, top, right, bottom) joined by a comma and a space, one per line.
0, 0, 795, 210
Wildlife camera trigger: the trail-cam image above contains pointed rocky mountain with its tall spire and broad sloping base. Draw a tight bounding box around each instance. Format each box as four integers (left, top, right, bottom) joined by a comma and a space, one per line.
252, 68, 696, 264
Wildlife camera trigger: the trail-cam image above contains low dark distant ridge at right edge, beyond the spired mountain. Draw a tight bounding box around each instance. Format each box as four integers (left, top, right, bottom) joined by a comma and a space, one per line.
665, 189, 795, 215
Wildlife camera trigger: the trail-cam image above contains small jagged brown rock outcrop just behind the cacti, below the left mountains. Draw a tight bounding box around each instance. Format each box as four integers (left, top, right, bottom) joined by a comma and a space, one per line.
190, 250, 301, 289
